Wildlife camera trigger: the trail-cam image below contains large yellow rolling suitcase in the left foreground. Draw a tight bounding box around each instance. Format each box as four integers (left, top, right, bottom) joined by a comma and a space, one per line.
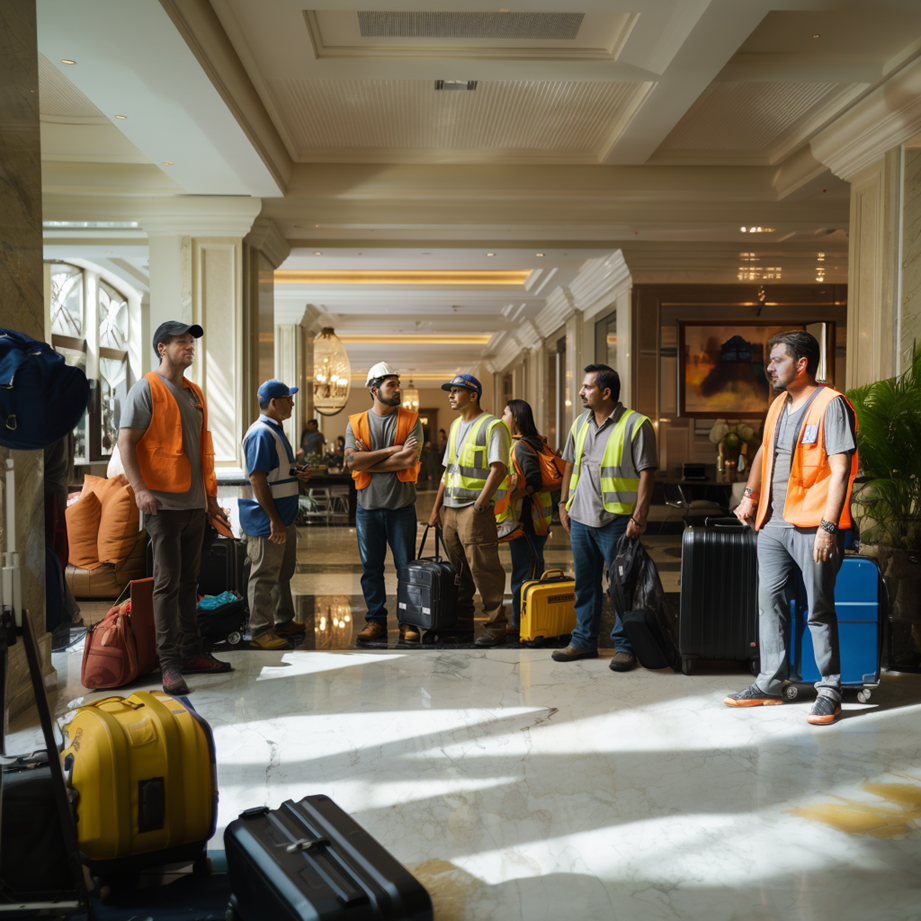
61, 691, 217, 874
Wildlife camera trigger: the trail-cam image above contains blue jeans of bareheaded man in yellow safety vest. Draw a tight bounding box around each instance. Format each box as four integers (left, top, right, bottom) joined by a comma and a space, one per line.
569, 515, 633, 655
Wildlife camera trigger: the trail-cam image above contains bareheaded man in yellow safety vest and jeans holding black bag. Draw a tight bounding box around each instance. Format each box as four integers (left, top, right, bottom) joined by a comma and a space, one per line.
553, 364, 658, 672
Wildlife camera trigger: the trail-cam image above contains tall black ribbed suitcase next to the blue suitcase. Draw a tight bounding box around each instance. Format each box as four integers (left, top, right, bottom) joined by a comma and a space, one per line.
678, 518, 759, 675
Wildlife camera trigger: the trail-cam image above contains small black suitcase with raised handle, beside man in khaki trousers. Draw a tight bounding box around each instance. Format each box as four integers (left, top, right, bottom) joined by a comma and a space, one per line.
397, 527, 457, 643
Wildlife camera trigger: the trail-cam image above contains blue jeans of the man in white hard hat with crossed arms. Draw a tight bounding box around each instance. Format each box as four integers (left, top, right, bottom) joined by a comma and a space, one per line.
355, 505, 416, 627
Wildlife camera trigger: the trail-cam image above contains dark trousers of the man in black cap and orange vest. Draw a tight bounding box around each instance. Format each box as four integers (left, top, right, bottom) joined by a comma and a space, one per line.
144, 509, 206, 668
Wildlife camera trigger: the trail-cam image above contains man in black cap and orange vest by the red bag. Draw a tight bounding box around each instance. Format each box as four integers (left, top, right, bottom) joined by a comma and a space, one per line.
118, 320, 231, 695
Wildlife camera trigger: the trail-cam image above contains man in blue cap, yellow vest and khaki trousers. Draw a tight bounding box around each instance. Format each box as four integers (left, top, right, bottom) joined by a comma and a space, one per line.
429, 374, 512, 646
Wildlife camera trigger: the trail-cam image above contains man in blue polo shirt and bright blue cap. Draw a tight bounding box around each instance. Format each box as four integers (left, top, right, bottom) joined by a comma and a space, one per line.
240, 380, 310, 649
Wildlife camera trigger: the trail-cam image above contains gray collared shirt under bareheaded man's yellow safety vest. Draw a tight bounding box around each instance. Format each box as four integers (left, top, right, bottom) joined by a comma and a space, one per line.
563, 403, 659, 528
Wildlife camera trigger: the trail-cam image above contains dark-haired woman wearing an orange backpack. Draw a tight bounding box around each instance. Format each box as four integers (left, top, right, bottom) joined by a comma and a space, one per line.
502, 400, 563, 639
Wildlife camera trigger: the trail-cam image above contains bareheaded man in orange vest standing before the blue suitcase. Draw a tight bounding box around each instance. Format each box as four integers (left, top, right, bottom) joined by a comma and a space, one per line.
724, 331, 857, 725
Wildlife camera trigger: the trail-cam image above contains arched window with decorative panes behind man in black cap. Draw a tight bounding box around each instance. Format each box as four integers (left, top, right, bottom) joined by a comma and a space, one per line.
49, 262, 131, 463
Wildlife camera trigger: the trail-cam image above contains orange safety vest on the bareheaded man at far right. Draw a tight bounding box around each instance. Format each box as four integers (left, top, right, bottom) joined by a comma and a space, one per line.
755, 386, 857, 529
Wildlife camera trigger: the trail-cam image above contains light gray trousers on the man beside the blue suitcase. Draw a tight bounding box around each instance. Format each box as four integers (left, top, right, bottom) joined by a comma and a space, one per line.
755, 527, 844, 700
